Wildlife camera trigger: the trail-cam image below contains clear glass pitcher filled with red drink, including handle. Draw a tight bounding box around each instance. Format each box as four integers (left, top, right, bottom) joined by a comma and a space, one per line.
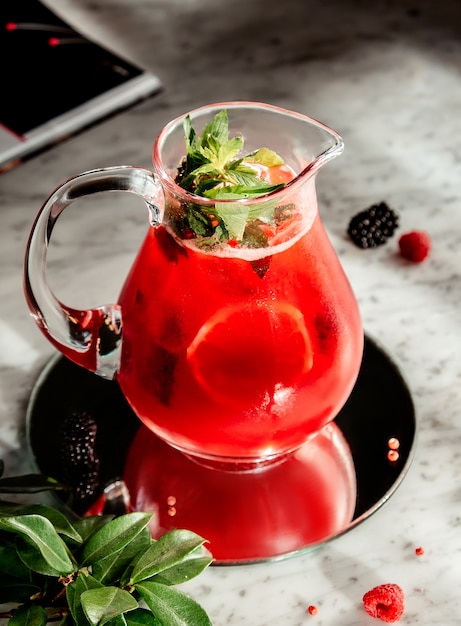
24, 102, 363, 471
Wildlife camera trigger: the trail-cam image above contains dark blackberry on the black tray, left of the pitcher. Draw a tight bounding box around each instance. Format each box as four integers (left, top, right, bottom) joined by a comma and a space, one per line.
60, 412, 100, 513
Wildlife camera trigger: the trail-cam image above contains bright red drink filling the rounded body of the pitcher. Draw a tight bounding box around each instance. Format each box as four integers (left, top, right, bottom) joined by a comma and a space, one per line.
118, 185, 363, 460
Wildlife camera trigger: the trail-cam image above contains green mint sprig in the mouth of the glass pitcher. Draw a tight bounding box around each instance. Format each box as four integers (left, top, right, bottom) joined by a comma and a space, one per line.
171, 109, 285, 247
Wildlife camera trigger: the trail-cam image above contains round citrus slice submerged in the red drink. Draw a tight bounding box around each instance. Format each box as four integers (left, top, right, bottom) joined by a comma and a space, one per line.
187, 302, 312, 406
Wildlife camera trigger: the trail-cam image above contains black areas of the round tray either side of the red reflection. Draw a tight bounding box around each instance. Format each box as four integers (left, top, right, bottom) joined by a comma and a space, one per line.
27, 336, 416, 539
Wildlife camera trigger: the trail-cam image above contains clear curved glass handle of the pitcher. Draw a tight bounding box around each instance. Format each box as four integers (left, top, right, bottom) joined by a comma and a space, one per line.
24, 166, 163, 378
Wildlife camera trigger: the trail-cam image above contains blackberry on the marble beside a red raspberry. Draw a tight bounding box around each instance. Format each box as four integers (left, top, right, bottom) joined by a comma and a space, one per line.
347, 202, 399, 248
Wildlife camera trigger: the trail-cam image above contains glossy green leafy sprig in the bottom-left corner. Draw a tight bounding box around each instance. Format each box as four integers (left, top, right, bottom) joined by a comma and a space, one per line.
0, 461, 213, 626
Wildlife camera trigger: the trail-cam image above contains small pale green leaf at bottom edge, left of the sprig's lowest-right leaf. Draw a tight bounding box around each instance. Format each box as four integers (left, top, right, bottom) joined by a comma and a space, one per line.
80, 587, 138, 626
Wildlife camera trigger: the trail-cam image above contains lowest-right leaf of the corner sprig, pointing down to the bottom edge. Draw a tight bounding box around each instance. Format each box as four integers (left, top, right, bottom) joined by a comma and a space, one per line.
136, 581, 212, 626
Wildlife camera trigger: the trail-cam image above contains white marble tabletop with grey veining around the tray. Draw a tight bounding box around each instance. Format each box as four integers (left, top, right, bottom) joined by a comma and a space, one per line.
0, 0, 461, 626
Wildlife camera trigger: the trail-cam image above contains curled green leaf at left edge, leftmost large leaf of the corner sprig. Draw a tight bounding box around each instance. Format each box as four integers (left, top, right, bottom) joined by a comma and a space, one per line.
0, 515, 74, 576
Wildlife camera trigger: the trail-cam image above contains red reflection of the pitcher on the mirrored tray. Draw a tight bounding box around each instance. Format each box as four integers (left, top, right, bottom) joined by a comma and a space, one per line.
124, 424, 356, 564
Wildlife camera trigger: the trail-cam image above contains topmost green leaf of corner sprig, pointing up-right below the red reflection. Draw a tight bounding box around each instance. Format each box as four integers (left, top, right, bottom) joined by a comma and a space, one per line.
82, 513, 152, 566
